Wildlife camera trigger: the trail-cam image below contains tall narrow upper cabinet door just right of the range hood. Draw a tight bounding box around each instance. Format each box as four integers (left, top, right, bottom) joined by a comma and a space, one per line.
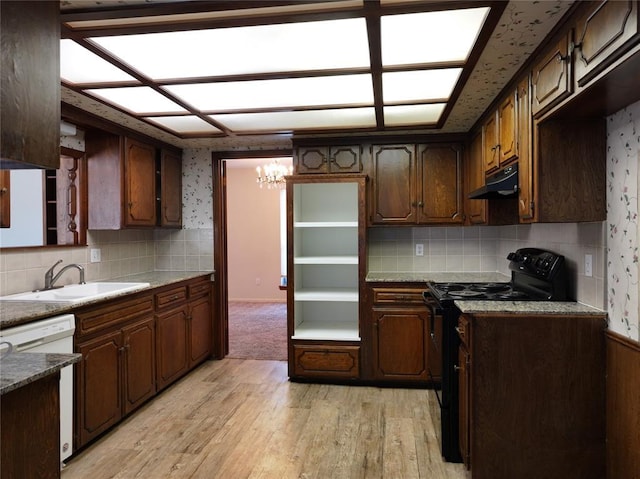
517, 76, 534, 221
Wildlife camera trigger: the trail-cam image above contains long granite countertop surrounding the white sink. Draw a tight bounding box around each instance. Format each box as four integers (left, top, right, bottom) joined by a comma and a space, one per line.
0, 271, 213, 329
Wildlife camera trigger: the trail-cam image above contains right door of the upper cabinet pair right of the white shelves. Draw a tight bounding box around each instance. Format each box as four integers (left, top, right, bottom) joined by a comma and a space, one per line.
418, 144, 464, 224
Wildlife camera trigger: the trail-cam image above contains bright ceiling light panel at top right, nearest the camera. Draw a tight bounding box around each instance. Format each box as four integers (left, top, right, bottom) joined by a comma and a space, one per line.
380, 7, 489, 66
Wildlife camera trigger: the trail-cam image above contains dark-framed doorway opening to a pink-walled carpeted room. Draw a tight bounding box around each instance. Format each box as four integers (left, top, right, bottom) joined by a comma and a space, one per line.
212, 150, 291, 360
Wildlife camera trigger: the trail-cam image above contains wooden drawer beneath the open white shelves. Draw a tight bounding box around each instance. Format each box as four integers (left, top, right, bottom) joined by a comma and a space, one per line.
293, 345, 360, 379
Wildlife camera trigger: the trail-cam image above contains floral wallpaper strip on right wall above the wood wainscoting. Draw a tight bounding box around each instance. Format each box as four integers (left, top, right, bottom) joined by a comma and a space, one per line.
607, 102, 640, 341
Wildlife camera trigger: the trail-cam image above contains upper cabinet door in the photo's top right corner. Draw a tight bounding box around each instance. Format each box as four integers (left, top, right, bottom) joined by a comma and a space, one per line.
575, 0, 640, 87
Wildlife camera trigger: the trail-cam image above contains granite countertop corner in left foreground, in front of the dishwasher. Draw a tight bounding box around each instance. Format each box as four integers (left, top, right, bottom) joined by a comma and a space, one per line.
0, 352, 82, 395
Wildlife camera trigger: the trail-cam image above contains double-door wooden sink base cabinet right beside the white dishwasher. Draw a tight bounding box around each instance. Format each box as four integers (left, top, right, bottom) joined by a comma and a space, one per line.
75, 294, 156, 449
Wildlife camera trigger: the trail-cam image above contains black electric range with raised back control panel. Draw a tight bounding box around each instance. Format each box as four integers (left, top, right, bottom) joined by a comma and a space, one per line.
423, 248, 567, 462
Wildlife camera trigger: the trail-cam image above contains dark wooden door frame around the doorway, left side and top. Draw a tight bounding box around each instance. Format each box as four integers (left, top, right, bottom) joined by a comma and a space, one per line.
211, 148, 293, 359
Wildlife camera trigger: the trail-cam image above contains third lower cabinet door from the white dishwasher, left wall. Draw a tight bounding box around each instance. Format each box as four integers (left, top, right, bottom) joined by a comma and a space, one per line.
156, 305, 189, 390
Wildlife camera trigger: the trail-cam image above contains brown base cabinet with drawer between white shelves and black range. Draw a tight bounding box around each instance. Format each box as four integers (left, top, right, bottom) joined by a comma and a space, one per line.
369, 284, 442, 384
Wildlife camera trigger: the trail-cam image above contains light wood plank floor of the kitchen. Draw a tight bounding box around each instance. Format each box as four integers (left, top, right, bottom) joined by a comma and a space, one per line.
62, 359, 465, 479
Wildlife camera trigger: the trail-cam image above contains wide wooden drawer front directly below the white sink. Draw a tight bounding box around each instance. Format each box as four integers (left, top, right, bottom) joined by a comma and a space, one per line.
76, 295, 153, 336
